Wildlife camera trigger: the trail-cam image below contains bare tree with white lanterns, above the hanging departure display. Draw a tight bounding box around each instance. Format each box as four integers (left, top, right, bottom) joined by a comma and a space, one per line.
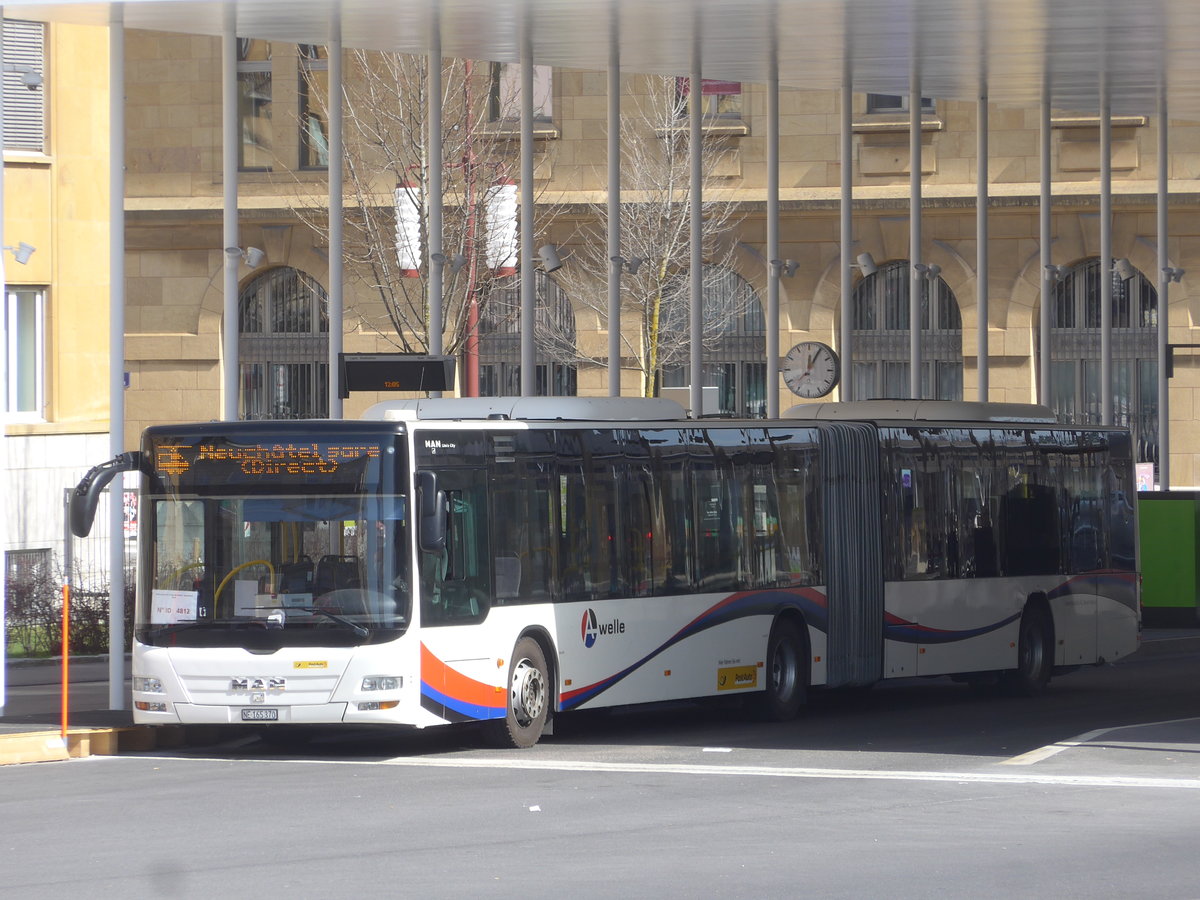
296, 50, 552, 364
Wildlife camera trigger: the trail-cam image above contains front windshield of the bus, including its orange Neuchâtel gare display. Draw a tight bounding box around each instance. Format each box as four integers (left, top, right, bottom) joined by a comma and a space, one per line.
134, 439, 410, 649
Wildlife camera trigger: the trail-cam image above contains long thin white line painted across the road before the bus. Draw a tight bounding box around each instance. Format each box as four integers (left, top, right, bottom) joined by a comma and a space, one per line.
117, 756, 1200, 791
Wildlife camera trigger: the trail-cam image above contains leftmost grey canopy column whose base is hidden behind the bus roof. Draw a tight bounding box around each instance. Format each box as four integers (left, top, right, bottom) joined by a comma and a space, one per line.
221, 10, 241, 421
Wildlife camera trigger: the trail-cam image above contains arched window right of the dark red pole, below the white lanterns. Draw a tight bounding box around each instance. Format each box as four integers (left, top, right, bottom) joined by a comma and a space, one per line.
479, 271, 578, 397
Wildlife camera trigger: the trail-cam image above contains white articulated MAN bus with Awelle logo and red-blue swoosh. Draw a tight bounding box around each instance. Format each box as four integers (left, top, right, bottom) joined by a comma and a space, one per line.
72, 398, 1140, 746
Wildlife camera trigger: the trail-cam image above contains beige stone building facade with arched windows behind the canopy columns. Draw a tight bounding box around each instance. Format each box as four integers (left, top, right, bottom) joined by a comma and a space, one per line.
117, 31, 1200, 486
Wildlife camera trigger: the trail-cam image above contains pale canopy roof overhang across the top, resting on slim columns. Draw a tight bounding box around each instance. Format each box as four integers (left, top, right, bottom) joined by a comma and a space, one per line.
14, 0, 1200, 120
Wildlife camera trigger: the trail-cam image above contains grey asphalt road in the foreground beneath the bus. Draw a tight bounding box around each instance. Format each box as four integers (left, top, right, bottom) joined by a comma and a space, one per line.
0, 652, 1200, 900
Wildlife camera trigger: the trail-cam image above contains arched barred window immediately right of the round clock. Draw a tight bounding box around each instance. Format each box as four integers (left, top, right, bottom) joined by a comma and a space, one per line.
852, 259, 962, 400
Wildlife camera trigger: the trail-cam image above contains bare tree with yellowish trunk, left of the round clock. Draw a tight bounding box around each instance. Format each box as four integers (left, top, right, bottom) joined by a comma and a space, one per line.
563, 77, 750, 396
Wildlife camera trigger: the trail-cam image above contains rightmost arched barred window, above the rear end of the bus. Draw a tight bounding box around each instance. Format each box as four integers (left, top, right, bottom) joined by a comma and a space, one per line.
1039, 257, 1158, 462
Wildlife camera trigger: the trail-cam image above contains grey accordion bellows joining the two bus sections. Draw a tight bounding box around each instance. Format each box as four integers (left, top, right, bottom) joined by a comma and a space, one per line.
820, 422, 883, 688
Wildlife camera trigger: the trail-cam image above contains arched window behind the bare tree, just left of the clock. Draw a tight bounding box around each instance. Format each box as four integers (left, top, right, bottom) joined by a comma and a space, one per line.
660, 265, 767, 418
